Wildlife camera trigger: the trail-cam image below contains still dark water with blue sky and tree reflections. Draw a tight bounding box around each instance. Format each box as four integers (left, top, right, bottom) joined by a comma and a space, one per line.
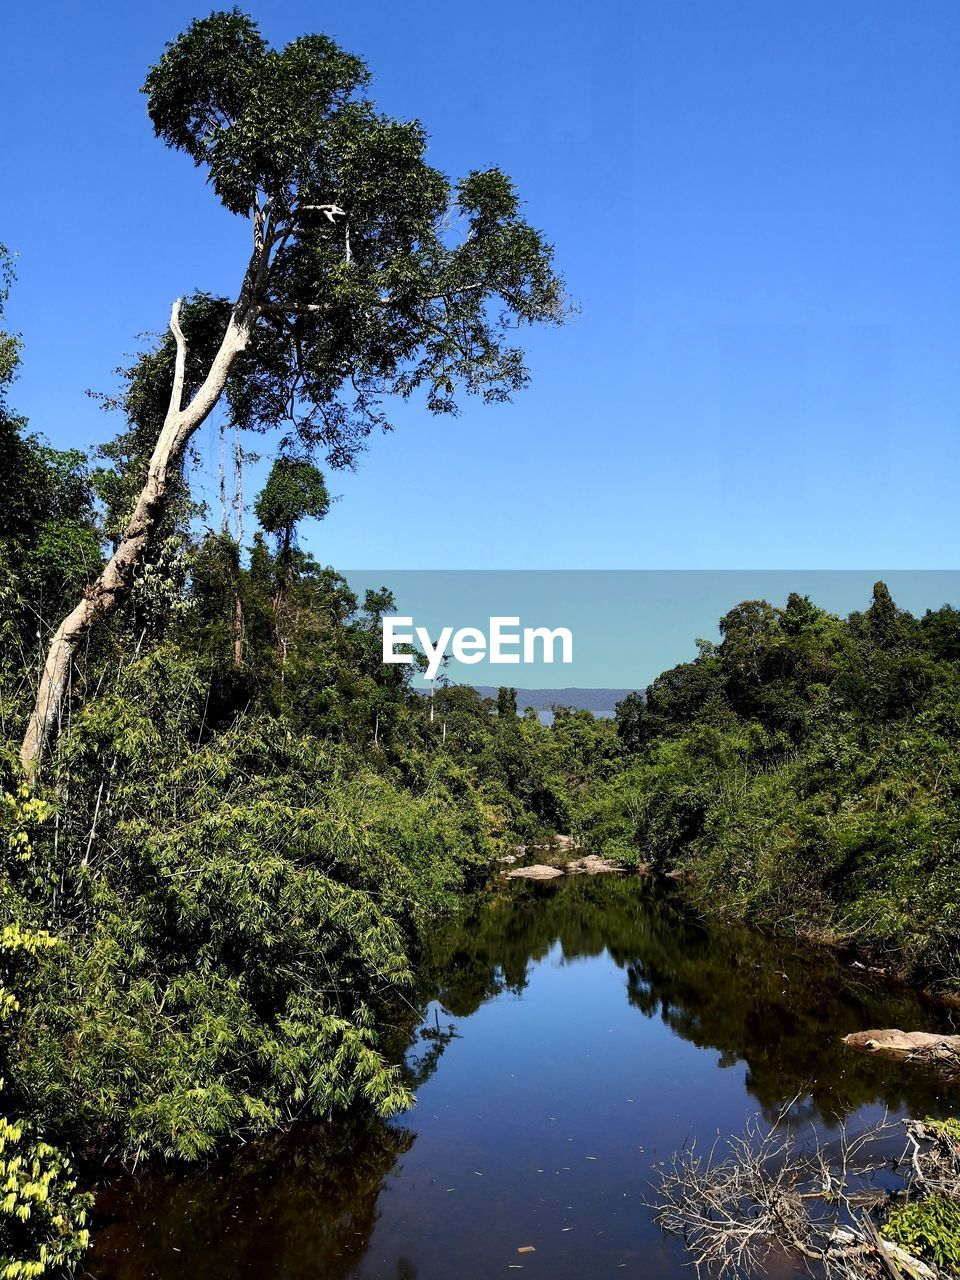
87, 877, 960, 1280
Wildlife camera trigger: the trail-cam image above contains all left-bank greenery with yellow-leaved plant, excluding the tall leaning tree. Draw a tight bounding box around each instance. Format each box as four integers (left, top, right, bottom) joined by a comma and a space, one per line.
0, 209, 576, 1277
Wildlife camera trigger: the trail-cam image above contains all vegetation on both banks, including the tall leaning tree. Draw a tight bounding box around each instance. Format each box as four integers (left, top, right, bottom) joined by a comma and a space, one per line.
0, 10, 960, 1280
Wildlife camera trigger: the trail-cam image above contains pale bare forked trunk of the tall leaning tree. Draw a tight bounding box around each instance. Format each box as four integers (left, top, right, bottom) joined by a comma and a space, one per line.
20, 293, 257, 777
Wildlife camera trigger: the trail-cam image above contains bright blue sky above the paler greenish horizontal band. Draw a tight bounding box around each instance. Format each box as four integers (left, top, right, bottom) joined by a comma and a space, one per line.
0, 0, 960, 570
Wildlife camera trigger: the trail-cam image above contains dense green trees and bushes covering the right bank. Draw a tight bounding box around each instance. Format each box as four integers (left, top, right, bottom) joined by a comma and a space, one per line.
577, 582, 960, 986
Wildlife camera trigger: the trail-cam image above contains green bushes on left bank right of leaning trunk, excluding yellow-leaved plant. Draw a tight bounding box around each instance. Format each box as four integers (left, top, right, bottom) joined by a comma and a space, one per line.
4, 407, 601, 1187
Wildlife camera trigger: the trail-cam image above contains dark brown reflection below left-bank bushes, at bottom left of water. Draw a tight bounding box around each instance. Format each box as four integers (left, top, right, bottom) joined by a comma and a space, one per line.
87, 1121, 416, 1280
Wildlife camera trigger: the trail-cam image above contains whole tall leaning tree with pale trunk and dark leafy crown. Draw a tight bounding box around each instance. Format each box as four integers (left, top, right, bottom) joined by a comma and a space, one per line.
22, 9, 563, 773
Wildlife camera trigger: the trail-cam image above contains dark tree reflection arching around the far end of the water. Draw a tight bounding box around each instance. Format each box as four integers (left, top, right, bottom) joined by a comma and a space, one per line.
424, 877, 951, 1121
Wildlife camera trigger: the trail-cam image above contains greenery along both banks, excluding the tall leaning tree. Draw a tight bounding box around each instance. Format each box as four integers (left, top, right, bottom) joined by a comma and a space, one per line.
7, 235, 960, 1276
